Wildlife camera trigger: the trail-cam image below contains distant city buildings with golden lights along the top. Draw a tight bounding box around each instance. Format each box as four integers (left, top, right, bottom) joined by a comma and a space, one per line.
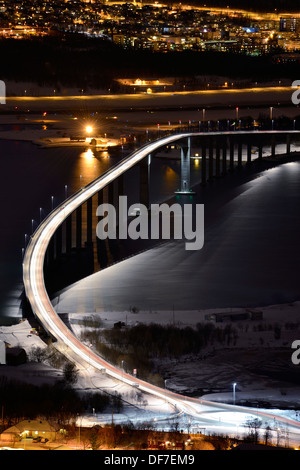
0, 0, 300, 55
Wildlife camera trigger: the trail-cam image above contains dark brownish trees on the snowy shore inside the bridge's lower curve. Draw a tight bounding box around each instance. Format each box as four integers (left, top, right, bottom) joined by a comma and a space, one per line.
80, 323, 237, 386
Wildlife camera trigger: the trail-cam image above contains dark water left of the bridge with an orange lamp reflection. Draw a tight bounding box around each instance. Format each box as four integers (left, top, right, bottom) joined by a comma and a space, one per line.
0, 141, 115, 323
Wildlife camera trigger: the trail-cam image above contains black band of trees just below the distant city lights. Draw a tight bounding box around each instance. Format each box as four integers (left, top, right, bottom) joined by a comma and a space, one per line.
0, 34, 297, 93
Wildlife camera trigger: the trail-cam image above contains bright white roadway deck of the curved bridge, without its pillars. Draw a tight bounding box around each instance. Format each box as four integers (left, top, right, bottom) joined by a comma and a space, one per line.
23, 132, 300, 432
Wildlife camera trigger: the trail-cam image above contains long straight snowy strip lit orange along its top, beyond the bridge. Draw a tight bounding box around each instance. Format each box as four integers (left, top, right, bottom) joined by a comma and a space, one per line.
1, 83, 296, 114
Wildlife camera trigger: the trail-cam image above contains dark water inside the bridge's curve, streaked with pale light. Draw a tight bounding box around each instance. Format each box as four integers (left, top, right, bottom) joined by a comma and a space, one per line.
57, 162, 300, 313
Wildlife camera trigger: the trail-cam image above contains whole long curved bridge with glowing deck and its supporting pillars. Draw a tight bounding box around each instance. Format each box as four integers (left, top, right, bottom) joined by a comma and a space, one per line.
23, 131, 300, 432
